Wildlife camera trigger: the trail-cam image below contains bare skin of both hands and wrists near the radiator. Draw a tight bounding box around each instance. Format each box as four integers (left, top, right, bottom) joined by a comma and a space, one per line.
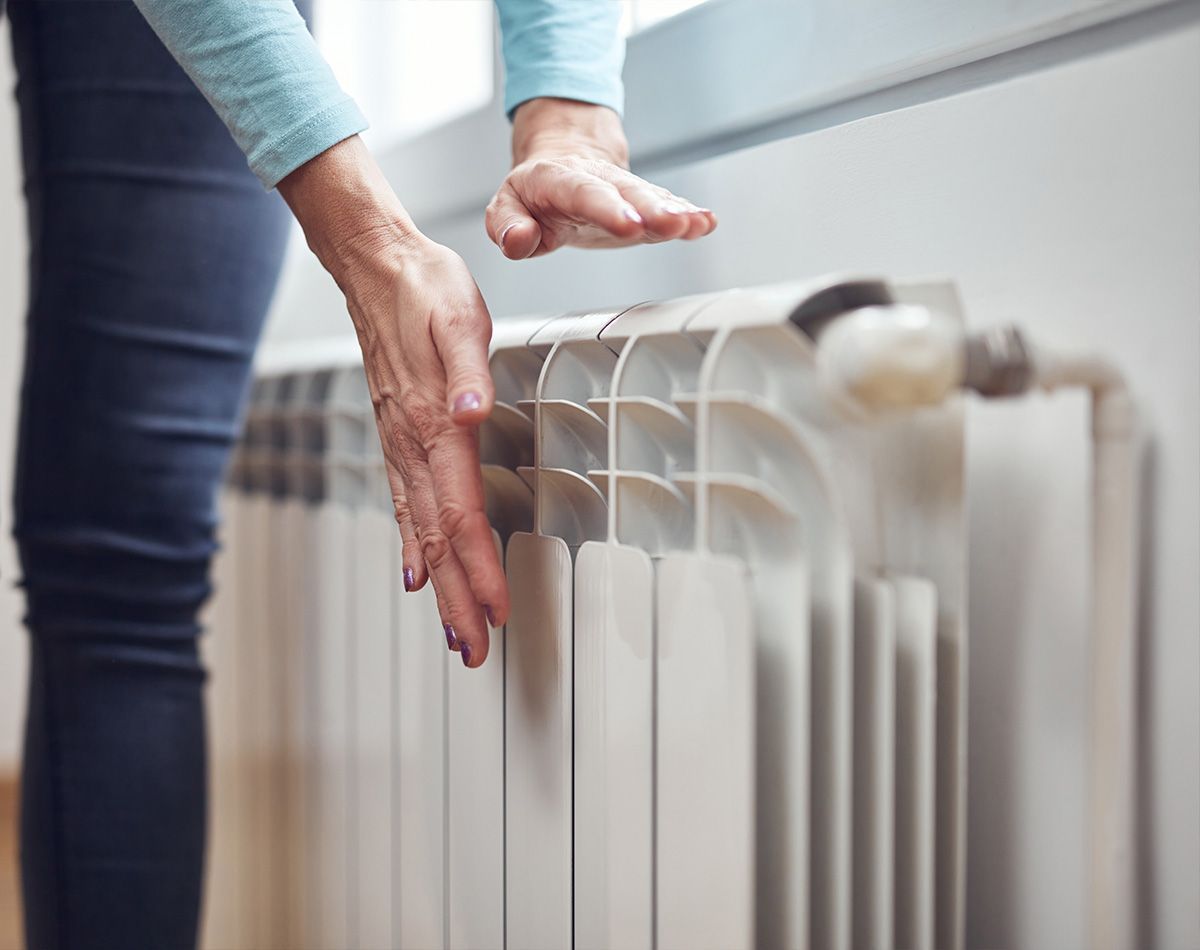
278, 98, 716, 667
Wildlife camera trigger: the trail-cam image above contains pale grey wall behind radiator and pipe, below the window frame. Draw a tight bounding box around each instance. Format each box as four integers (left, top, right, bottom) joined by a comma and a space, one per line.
271, 4, 1200, 950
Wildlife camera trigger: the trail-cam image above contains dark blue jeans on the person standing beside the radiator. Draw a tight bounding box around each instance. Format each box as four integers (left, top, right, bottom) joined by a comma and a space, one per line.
7, 0, 300, 950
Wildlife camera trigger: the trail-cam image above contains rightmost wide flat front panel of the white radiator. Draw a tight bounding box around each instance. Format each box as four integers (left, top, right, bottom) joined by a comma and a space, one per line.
655, 554, 755, 950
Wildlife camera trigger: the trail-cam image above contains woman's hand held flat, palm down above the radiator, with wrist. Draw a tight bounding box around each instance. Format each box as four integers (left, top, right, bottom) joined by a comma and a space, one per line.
486, 98, 716, 260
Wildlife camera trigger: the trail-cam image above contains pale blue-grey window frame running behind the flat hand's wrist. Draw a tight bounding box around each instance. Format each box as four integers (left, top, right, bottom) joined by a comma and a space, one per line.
380, 0, 1172, 224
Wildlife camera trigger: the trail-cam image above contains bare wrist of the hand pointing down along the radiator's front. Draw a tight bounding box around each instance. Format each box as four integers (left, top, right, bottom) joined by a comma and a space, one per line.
277, 136, 425, 281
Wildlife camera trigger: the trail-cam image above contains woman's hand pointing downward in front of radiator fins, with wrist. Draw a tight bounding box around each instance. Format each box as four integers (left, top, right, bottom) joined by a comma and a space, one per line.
280, 138, 509, 667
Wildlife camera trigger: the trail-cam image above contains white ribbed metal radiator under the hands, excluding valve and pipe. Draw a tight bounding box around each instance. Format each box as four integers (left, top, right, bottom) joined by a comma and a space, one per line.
205, 272, 1132, 950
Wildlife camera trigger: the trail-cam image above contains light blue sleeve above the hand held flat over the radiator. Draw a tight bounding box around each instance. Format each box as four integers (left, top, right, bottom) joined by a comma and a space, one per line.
496, 0, 625, 115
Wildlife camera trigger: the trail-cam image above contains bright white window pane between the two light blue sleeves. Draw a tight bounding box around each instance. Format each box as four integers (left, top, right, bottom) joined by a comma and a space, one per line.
313, 0, 494, 149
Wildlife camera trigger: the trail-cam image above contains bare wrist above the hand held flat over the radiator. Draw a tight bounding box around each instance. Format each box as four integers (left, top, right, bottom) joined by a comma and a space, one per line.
512, 98, 629, 168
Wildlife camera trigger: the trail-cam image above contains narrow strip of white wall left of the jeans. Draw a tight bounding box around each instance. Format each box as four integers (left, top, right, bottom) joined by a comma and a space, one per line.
0, 38, 25, 775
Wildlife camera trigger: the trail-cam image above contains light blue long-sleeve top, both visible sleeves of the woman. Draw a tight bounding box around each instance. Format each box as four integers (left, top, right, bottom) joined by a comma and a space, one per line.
134, 0, 624, 188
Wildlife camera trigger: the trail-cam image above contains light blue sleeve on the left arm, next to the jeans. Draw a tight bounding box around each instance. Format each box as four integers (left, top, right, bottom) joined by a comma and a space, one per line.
134, 0, 367, 188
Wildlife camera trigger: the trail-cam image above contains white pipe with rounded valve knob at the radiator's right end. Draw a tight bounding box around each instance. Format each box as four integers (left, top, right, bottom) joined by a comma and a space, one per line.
817, 305, 1141, 950
